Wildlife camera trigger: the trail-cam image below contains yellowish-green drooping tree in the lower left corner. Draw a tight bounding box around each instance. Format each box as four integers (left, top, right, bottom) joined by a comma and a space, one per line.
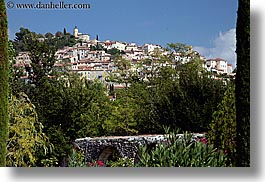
7, 93, 53, 167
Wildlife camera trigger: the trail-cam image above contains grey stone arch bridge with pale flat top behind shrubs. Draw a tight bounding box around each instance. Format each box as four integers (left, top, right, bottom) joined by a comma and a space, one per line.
74, 133, 204, 162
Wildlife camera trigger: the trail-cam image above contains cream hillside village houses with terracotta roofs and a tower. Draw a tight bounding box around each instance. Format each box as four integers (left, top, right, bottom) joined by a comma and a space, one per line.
15, 27, 233, 87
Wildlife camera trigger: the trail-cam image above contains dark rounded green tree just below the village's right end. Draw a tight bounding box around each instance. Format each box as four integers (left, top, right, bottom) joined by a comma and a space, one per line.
171, 59, 225, 132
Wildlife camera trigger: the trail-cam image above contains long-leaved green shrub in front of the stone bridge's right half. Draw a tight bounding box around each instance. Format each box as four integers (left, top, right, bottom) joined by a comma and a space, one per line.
136, 132, 227, 167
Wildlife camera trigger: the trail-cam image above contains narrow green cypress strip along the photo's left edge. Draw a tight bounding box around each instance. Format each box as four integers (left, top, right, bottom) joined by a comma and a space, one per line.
0, 0, 8, 167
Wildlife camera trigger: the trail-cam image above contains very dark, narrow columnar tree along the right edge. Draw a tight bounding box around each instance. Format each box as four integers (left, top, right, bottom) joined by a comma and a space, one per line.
236, 0, 250, 167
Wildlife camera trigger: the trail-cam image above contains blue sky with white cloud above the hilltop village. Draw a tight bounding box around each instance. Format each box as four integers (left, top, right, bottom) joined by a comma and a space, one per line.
6, 0, 238, 65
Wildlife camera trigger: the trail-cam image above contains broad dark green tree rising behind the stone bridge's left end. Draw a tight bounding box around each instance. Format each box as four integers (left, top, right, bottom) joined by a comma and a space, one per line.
27, 75, 111, 166
